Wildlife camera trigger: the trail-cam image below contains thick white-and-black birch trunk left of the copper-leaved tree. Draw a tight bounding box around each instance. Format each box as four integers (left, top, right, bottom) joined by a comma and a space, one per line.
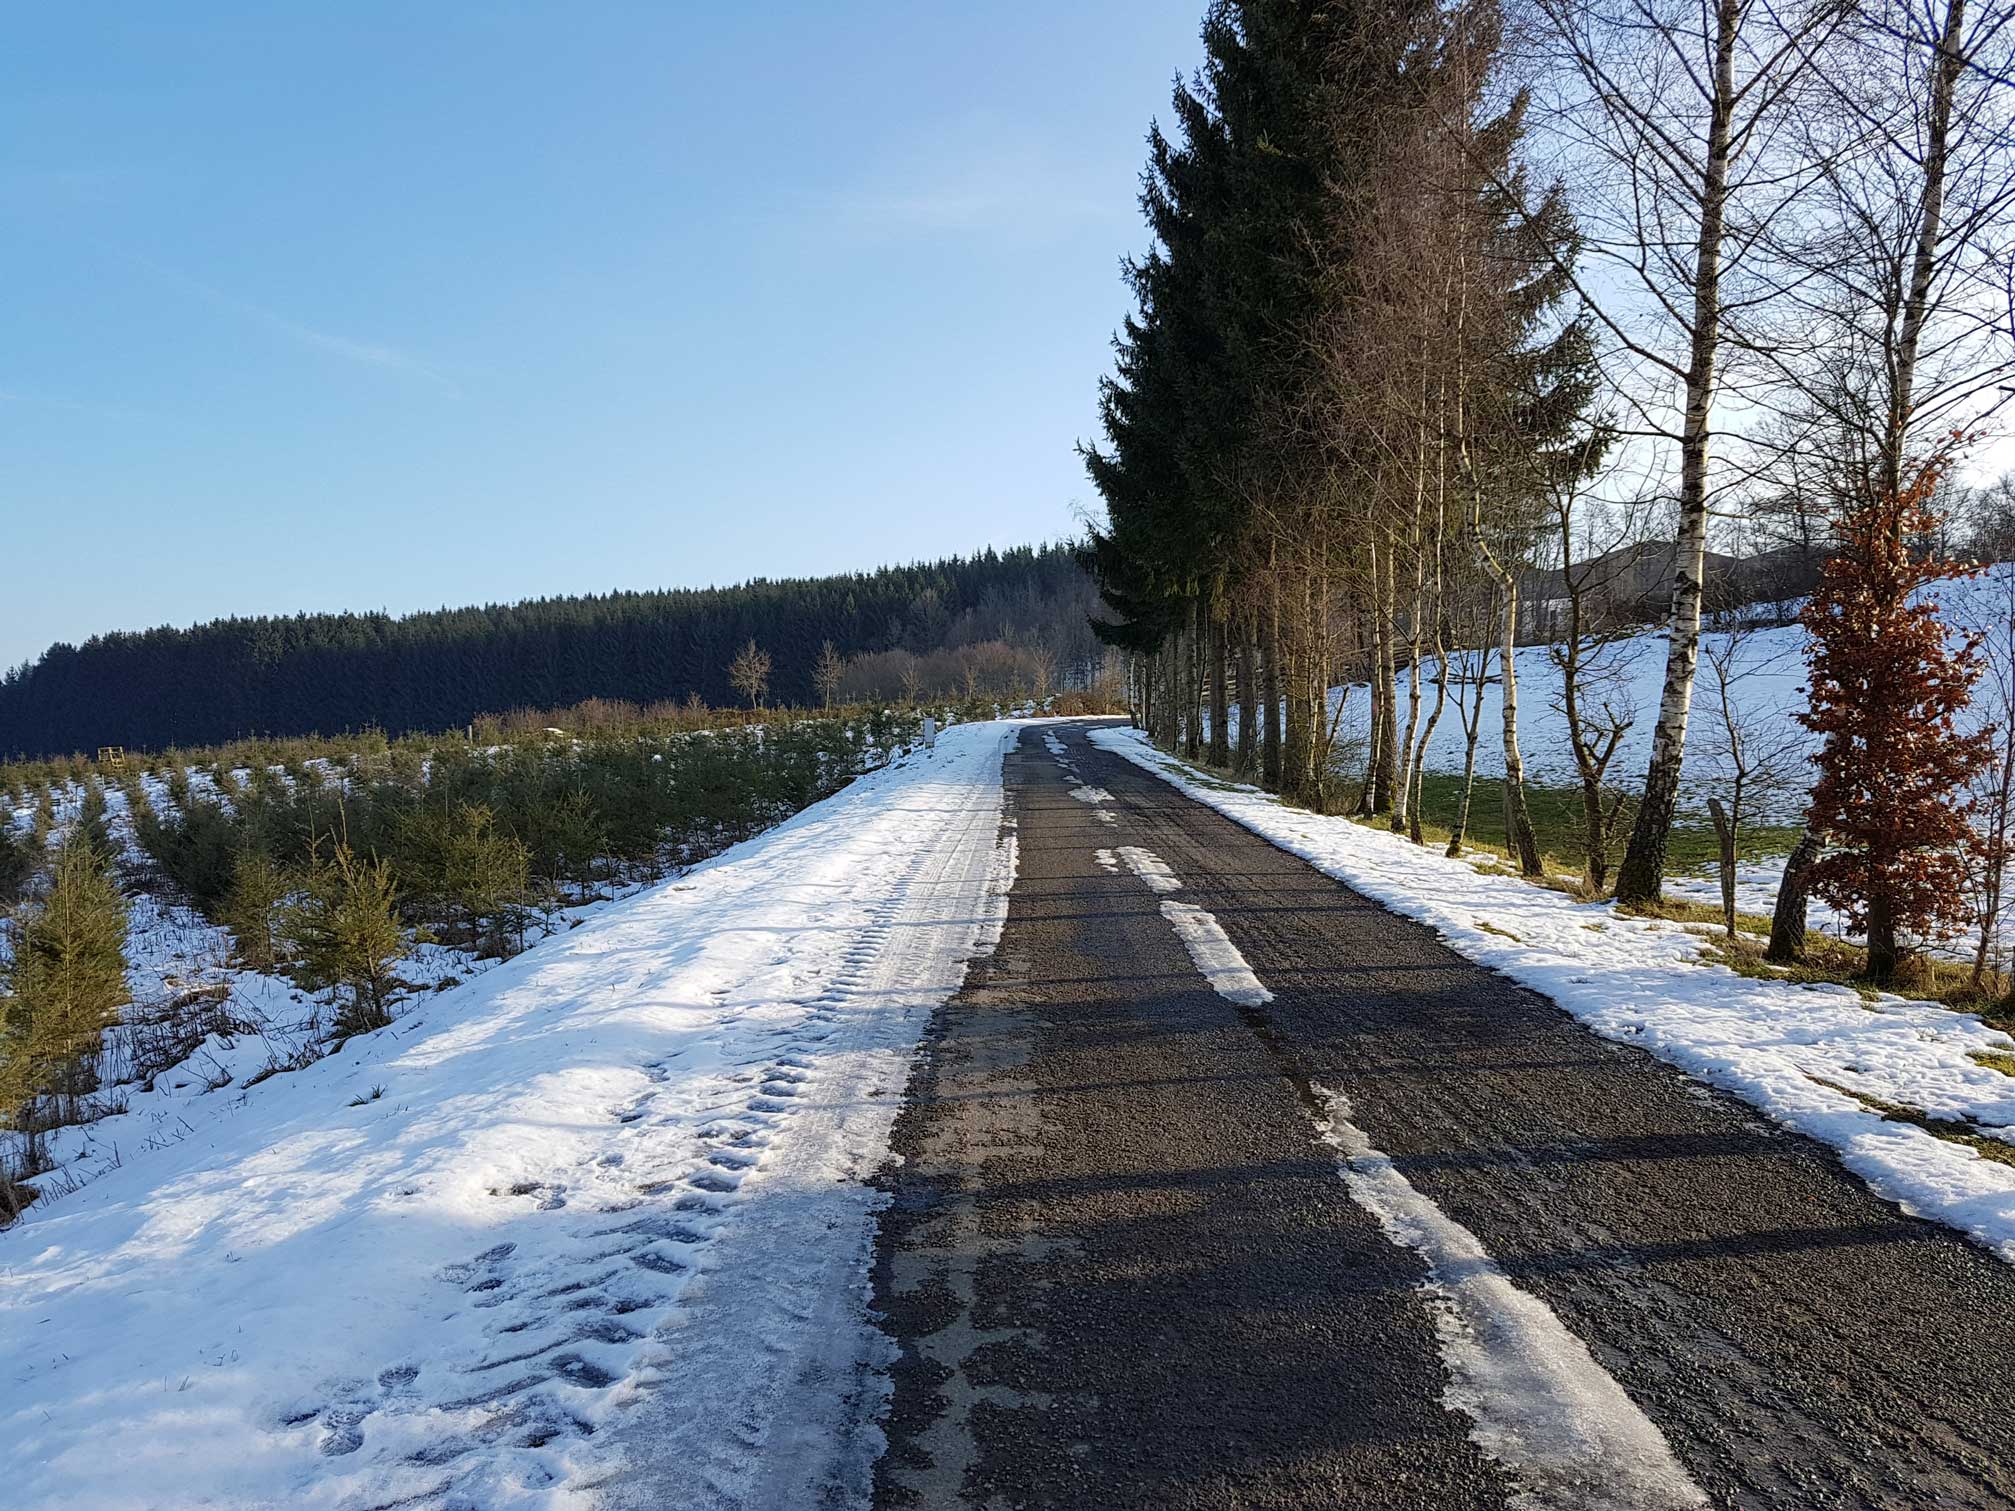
1616, 0, 1741, 907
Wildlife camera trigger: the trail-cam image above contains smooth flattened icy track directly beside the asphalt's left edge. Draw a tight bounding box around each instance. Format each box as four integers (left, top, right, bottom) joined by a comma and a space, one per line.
605, 735, 1016, 1511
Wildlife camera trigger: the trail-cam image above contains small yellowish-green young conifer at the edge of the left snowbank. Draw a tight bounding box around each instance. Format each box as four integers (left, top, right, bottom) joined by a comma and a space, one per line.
280, 842, 409, 1038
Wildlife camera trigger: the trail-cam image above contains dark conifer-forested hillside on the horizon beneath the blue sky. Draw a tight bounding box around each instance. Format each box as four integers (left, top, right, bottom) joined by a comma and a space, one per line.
0, 546, 1098, 756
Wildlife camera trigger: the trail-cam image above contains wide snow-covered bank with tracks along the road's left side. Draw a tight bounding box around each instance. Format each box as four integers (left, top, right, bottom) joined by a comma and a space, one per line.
0, 723, 1016, 1511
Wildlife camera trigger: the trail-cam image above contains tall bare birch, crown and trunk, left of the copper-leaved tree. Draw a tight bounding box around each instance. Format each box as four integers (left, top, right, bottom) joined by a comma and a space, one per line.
1531, 0, 1842, 905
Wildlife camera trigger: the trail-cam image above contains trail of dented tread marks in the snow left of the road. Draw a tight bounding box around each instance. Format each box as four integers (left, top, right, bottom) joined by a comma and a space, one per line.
280, 854, 979, 1507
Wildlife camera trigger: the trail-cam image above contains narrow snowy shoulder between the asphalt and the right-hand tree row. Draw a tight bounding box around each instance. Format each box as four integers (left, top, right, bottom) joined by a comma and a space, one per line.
1090, 727, 2015, 1263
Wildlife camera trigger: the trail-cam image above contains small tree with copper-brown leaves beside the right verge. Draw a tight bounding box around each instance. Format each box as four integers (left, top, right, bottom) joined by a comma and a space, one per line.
1799, 457, 1993, 981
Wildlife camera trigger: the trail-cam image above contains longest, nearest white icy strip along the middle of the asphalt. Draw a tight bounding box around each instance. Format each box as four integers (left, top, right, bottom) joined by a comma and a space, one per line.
1313, 1095, 1709, 1511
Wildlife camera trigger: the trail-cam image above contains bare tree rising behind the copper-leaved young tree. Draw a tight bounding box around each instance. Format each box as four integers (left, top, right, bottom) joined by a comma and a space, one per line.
1771, 0, 2015, 959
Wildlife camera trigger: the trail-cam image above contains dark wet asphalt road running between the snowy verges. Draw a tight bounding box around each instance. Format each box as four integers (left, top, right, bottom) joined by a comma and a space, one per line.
875, 725, 2015, 1511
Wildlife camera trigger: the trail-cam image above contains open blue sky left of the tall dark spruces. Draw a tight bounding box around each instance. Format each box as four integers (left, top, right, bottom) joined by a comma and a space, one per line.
0, 0, 1201, 667
